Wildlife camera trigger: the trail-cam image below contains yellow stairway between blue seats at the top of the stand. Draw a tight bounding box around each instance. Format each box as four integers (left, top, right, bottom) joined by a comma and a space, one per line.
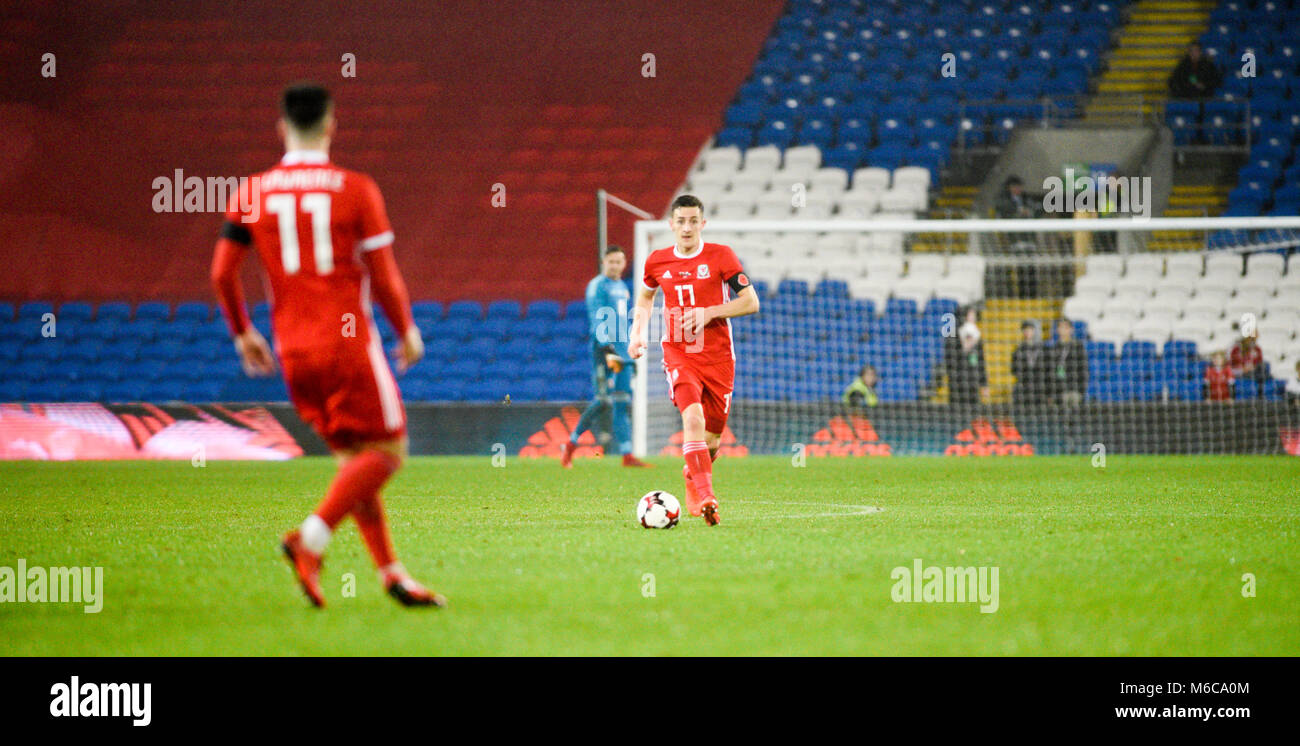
1084, 0, 1216, 122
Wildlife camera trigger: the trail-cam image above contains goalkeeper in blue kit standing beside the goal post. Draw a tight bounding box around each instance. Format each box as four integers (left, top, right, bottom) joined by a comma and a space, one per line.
560, 246, 649, 469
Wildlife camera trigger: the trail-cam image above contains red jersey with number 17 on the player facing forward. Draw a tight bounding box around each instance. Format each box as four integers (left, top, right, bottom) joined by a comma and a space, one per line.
641, 243, 749, 364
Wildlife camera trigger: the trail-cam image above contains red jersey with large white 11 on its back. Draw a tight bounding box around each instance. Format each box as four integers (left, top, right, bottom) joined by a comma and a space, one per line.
226, 151, 393, 354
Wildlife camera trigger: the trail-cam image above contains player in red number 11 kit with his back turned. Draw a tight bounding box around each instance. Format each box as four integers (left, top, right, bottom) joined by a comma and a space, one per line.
212, 84, 446, 607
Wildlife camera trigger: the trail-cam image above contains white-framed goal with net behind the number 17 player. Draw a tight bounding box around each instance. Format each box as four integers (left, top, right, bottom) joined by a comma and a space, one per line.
633, 217, 1300, 459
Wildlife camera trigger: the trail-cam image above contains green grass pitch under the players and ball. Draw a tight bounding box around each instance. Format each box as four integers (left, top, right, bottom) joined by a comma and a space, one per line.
0, 456, 1300, 655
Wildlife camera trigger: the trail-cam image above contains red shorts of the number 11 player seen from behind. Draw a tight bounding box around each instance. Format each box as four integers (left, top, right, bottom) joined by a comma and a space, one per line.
281, 338, 406, 450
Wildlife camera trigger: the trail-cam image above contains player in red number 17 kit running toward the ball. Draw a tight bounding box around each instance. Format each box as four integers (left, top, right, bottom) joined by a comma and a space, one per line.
628, 195, 758, 526
